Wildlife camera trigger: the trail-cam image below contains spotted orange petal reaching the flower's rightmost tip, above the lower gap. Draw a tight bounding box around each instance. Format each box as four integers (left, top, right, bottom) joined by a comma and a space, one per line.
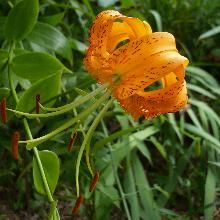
114, 51, 188, 99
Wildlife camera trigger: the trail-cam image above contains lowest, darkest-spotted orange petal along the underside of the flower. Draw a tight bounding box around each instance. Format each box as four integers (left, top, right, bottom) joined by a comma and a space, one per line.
119, 81, 188, 120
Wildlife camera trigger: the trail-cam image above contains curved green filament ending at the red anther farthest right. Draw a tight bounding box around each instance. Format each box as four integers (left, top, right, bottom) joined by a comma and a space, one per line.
86, 98, 114, 176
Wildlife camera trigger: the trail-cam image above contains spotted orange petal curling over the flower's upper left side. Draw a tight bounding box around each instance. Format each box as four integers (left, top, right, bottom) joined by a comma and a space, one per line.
84, 10, 151, 81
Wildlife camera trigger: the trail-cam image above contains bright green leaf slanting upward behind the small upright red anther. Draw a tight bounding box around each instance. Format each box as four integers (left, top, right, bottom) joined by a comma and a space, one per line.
16, 71, 62, 112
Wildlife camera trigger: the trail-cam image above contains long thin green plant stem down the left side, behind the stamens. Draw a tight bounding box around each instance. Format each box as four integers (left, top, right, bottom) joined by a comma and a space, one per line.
8, 44, 54, 211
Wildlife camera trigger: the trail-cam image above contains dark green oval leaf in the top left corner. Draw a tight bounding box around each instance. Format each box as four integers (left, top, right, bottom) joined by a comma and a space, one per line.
5, 0, 39, 41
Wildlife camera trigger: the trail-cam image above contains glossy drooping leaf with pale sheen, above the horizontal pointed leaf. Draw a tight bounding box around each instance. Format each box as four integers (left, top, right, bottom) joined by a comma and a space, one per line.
28, 22, 73, 64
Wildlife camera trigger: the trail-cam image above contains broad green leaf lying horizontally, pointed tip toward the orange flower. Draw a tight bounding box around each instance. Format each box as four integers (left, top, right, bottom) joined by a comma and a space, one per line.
12, 52, 70, 82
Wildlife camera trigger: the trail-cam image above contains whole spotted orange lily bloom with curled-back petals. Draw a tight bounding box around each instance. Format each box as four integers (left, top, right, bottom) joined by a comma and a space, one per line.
84, 10, 188, 119
